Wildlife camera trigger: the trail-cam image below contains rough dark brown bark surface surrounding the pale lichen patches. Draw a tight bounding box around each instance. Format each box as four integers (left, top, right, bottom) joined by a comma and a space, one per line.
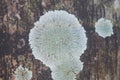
0, 0, 120, 80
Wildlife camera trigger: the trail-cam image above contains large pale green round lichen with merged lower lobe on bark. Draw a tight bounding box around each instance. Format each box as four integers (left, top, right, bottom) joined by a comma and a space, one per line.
29, 10, 87, 80
